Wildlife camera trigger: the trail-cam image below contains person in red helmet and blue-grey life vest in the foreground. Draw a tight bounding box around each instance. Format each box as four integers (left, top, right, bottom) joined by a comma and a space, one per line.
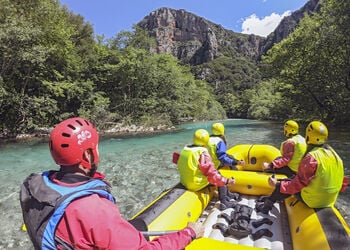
20, 117, 203, 249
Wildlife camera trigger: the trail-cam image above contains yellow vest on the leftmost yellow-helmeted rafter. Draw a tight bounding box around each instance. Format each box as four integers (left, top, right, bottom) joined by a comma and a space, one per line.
177, 146, 209, 191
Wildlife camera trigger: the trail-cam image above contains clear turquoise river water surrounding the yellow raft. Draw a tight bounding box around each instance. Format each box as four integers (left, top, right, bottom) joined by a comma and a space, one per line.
0, 120, 350, 249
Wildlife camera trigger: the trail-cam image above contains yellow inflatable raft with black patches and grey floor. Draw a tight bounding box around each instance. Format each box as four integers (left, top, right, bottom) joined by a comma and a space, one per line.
130, 145, 350, 250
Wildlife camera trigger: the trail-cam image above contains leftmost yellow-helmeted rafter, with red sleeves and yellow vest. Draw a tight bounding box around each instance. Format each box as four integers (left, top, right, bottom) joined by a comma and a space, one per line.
177, 129, 236, 207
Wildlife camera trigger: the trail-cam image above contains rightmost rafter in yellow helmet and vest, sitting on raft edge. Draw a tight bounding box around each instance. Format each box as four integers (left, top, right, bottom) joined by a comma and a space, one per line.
256, 121, 344, 214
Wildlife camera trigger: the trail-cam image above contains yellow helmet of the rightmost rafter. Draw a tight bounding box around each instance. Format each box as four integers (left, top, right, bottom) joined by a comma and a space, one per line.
306, 121, 328, 145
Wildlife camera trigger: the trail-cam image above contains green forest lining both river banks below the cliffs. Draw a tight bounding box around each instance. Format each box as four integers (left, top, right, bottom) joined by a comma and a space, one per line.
0, 0, 350, 136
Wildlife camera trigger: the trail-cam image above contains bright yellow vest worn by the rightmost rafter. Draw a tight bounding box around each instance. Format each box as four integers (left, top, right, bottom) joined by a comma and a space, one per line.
301, 146, 344, 208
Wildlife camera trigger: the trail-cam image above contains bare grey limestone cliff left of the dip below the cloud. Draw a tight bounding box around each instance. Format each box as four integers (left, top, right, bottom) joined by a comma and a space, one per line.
138, 8, 261, 65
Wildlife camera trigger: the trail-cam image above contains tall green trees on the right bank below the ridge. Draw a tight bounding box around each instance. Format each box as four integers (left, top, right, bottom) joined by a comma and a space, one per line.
263, 0, 350, 123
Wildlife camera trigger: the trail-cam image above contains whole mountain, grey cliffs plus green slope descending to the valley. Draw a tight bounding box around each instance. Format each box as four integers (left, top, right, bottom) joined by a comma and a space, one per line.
138, 0, 319, 118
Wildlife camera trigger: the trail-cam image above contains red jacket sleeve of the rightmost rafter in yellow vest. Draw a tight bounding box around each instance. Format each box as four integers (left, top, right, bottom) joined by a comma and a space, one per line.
280, 154, 317, 194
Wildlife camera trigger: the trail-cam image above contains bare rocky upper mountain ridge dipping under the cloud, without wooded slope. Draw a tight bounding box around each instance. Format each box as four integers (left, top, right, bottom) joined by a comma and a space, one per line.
138, 0, 319, 65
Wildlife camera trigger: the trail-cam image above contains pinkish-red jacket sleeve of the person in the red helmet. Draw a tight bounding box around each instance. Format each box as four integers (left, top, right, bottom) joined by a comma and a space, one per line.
56, 195, 195, 250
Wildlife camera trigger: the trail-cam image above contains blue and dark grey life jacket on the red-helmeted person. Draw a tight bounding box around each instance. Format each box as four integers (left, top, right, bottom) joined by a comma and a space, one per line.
20, 171, 115, 249
